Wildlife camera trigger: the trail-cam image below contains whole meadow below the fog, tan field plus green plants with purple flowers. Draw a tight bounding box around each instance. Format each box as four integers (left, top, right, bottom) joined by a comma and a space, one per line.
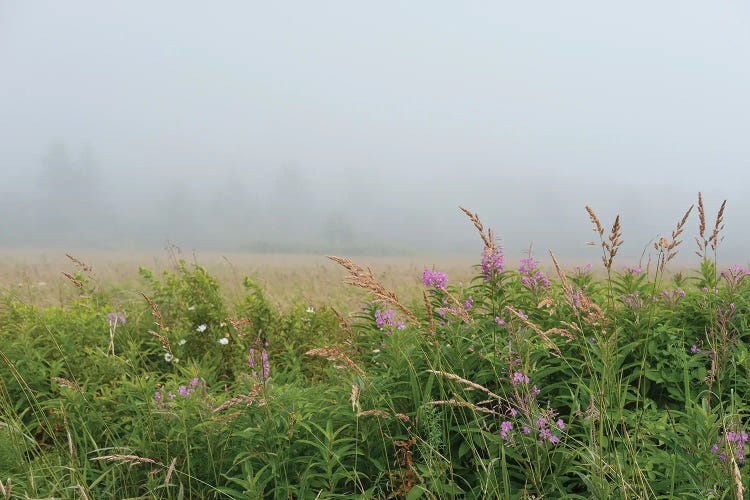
0, 198, 750, 499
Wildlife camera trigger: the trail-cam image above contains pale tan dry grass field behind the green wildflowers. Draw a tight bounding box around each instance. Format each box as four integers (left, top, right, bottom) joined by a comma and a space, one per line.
0, 249, 479, 310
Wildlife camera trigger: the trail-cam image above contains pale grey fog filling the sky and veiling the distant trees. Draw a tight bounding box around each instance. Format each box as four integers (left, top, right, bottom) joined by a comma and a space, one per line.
0, 0, 750, 262
